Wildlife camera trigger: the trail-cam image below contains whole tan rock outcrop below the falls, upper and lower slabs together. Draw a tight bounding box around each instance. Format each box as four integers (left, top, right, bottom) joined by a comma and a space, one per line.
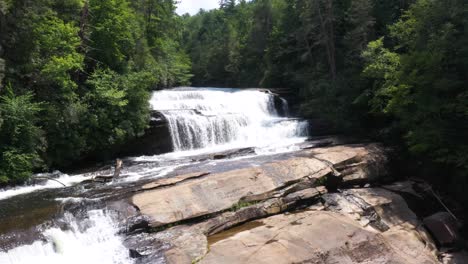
126, 144, 450, 264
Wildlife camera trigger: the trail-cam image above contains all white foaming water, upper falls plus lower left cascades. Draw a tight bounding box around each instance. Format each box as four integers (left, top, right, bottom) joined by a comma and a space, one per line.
0, 88, 308, 264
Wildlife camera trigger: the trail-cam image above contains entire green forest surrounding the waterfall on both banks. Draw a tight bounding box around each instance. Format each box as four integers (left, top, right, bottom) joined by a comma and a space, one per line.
0, 0, 468, 203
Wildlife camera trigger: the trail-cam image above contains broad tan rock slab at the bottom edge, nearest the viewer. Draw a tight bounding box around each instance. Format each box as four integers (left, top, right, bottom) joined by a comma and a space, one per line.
200, 211, 438, 264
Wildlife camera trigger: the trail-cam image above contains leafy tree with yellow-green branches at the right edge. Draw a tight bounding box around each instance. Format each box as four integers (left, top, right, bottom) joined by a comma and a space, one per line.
364, 0, 468, 168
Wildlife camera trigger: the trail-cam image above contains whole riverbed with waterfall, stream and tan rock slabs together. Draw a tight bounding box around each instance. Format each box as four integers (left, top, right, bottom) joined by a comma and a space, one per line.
0, 88, 466, 264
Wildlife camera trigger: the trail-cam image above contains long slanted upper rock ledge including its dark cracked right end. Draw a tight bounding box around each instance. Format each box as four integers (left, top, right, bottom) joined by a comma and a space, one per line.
131, 144, 386, 227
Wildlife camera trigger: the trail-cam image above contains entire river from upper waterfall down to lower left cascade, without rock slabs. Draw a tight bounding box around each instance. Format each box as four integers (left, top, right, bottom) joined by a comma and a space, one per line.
0, 87, 308, 264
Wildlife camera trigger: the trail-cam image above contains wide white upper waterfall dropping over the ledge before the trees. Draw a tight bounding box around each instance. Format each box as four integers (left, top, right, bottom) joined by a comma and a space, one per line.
150, 88, 307, 151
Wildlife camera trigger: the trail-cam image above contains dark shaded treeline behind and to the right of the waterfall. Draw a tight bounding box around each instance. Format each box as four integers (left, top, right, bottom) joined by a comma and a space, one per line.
183, 0, 468, 201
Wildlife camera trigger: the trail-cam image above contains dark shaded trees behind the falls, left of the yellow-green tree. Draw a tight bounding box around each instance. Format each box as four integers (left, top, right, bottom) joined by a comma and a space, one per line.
184, 0, 409, 130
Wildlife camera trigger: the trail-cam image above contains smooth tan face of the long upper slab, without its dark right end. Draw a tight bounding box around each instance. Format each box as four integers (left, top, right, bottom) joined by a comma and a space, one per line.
132, 158, 331, 226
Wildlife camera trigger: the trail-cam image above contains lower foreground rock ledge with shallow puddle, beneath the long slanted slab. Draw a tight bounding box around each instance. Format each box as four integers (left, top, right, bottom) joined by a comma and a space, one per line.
126, 184, 444, 264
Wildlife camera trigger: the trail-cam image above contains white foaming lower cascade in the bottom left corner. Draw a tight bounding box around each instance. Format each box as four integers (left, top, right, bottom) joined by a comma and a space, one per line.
0, 210, 133, 264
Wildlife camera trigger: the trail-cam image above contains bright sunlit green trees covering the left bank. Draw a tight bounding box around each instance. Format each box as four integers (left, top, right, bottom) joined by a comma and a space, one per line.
0, 0, 191, 184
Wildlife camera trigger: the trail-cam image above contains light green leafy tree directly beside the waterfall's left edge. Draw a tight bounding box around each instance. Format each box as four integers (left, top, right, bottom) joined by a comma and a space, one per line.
84, 69, 155, 151
